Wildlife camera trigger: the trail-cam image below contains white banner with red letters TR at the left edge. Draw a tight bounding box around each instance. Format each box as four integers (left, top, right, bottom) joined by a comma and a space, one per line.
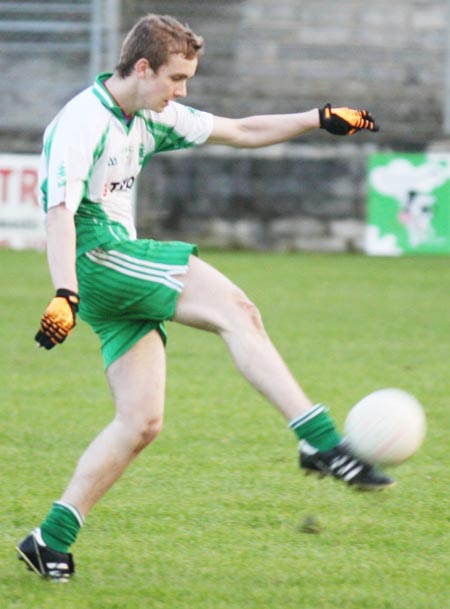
0, 154, 45, 249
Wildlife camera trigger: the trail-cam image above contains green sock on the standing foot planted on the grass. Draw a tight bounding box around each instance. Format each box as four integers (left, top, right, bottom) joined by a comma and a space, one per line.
41, 501, 84, 553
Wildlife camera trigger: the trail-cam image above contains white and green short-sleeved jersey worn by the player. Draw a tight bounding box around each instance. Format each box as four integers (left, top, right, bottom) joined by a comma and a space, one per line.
40, 73, 213, 255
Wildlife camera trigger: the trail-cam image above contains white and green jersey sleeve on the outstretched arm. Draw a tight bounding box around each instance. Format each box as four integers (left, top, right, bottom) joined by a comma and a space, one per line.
147, 102, 214, 152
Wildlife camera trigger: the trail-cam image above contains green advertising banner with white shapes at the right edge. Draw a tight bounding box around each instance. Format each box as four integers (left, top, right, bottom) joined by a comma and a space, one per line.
365, 153, 450, 256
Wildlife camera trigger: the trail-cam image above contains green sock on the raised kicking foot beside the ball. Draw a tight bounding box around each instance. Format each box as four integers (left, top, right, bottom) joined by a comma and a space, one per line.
289, 404, 341, 451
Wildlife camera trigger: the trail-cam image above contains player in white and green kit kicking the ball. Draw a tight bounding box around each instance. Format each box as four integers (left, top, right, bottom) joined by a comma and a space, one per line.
17, 14, 393, 582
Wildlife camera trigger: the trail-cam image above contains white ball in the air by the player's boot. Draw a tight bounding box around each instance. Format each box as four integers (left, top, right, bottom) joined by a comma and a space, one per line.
344, 389, 426, 465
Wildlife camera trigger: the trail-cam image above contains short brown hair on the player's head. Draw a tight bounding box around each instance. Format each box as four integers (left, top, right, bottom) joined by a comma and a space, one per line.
116, 14, 204, 78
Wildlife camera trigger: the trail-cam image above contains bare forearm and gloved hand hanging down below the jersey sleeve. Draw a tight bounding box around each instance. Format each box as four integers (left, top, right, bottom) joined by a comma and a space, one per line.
35, 203, 80, 349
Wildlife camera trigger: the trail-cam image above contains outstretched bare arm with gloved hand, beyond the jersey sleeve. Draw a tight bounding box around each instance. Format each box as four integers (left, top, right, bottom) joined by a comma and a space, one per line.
207, 104, 378, 148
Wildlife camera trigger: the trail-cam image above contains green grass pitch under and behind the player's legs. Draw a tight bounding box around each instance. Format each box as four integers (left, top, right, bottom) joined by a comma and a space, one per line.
0, 250, 450, 609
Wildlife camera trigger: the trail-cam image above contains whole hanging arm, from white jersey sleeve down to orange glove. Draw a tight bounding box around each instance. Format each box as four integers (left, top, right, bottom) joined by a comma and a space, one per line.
35, 95, 98, 349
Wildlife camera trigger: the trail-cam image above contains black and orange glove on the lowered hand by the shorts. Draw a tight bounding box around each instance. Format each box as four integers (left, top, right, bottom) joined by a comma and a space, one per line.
34, 289, 80, 349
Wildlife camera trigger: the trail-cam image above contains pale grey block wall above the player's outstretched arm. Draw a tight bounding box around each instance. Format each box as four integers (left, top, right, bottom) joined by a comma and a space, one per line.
123, 0, 450, 147
